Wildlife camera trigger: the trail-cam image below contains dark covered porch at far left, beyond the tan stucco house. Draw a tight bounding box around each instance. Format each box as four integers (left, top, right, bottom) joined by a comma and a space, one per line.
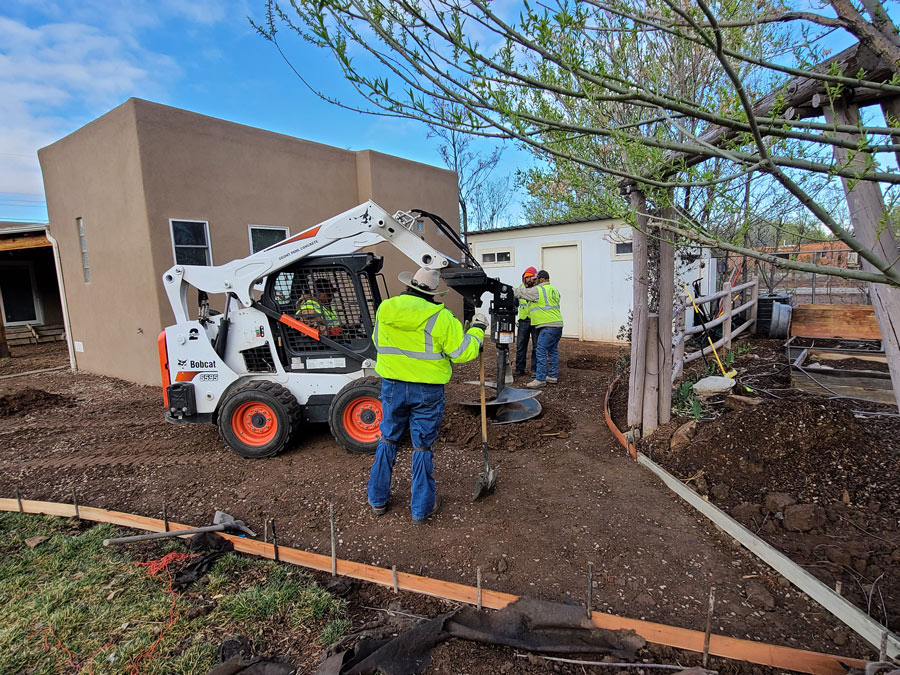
0, 222, 64, 346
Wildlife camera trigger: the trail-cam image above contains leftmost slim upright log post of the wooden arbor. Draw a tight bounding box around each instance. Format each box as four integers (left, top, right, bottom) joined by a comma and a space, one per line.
628, 190, 650, 429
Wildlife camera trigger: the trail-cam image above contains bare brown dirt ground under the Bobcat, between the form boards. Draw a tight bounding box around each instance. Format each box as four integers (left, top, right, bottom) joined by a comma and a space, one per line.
0, 340, 870, 673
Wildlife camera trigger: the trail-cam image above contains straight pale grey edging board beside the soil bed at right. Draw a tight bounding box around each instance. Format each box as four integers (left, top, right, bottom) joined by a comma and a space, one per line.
638, 453, 900, 658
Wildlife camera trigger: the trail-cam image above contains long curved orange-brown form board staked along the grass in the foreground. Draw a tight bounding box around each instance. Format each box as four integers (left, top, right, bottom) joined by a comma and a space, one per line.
0, 499, 866, 675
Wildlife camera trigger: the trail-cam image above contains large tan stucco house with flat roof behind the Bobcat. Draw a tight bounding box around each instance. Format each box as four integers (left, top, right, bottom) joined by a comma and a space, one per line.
38, 98, 461, 384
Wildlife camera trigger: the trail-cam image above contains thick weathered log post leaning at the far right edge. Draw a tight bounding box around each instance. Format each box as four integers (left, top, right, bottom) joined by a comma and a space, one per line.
823, 101, 900, 406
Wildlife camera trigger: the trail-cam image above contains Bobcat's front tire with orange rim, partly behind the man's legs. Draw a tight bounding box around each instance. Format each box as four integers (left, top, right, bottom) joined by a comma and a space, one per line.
328, 377, 381, 455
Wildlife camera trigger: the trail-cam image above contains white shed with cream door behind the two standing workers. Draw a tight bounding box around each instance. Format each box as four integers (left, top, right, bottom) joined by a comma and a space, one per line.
468, 216, 715, 342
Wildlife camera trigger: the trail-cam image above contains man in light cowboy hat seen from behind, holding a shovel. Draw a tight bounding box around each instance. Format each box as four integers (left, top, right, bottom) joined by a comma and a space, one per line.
367, 268, 487, 524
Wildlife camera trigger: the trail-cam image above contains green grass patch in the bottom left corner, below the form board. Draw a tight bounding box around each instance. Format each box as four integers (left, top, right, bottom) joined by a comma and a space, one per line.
0, 513, 350, 675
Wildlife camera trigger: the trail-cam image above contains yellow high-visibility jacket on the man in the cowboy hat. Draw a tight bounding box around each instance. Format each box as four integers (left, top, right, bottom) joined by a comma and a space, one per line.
372, 294, 484, 384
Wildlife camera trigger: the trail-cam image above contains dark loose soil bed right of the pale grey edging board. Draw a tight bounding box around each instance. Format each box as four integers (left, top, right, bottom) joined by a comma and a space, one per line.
628, 344, 900, 644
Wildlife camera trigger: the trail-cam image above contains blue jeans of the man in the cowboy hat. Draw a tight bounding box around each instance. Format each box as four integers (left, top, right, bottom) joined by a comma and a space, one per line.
366, 379, 444, 520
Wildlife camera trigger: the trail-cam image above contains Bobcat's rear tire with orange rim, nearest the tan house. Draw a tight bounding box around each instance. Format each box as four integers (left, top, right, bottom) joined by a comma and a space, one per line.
218, 380, 302, 459
